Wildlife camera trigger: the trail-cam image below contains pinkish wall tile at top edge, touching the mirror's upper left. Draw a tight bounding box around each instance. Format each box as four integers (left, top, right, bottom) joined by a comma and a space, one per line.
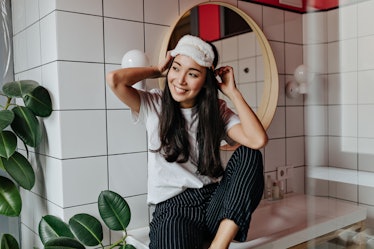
144, 0, 178, 25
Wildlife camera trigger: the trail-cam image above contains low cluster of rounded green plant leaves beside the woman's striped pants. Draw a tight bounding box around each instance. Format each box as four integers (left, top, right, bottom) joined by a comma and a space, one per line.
39, 190, 135, 249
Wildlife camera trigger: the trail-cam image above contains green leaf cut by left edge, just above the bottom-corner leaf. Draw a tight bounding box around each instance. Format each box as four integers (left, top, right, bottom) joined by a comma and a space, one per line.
0, 176, 22, 216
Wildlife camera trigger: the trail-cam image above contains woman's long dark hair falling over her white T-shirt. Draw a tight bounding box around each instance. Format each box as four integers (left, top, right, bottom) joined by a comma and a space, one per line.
156, 43, 225, 177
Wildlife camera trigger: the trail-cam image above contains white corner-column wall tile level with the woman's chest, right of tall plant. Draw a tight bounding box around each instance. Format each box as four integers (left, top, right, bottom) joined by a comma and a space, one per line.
58, 110, 107, 159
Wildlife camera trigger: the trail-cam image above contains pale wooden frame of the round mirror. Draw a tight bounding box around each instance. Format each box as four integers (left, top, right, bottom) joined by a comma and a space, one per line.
159, 1, 279, 129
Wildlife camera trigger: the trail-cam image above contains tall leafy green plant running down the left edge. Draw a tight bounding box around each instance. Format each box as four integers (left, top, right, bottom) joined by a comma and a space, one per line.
0, 80, 52, 249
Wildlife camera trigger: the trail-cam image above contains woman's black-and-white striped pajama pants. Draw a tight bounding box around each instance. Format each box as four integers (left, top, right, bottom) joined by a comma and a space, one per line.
149, 146, 264, 249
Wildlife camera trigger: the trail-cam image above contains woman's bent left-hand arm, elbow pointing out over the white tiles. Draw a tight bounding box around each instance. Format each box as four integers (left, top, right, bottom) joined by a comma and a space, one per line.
106, 53, 171, 112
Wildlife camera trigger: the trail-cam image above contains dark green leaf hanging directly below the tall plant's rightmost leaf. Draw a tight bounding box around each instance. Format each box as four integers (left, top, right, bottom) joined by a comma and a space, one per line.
11, 106, 42, 148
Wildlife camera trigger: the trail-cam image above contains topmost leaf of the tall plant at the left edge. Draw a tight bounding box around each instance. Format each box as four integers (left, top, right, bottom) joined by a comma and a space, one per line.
3, 80, 39, 98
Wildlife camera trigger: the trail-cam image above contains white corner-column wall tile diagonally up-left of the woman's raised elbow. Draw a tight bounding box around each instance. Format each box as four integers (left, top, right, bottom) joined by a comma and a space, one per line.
55, 11, 104, 62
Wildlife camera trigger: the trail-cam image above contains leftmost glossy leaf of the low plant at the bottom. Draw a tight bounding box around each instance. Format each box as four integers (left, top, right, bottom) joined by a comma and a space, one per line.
39, 215, 74, 245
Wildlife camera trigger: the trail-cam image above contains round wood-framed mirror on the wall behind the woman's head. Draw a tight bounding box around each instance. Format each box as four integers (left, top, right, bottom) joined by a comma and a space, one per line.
160, 2, 278, 129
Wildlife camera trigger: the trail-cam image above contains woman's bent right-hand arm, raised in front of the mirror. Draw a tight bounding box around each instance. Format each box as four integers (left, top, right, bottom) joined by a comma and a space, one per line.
216, 66, 268, 149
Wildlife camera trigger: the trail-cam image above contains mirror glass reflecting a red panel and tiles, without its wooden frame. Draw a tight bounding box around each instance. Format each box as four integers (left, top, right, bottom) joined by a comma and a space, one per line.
168, 4, 264, 114
